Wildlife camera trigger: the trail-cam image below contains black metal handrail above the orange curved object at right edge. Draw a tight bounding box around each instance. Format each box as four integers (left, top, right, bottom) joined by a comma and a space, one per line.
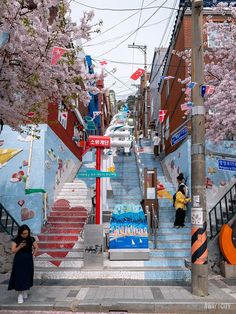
208, 183, 236, 238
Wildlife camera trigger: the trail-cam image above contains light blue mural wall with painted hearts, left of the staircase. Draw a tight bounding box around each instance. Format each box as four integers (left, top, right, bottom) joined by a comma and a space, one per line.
0, 125, 80, 234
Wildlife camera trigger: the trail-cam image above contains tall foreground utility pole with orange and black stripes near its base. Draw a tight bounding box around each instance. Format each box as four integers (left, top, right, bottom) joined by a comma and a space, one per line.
191, 0, 208, 296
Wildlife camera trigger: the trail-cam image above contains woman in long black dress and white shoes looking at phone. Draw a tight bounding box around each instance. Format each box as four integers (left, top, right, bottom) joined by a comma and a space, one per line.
8, 225, 38, 303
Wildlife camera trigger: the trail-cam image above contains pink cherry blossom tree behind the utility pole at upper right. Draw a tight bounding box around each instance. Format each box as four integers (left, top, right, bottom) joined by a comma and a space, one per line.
172, 3, 236, 141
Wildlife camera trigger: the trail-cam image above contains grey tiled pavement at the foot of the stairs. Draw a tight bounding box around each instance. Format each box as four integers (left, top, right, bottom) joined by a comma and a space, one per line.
0, 275, 236, 314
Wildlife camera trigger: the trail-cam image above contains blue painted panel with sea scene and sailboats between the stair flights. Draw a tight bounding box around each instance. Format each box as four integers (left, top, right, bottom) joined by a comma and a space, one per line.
109, 204, 148, 249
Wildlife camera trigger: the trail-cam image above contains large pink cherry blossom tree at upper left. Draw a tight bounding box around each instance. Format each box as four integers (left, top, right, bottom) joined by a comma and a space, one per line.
0, 0, 98, 130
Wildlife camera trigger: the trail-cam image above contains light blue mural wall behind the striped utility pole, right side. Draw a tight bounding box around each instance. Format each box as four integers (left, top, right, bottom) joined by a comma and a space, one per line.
164, 138, 236, 210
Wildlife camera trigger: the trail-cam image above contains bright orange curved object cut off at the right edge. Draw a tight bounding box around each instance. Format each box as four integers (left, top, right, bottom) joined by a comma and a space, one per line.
219, 224, 236, 265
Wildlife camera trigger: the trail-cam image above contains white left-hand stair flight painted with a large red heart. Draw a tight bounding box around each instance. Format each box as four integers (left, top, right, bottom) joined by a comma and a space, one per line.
35, 180, 92, 272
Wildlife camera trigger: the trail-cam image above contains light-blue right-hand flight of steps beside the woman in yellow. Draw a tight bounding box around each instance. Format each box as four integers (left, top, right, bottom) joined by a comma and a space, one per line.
138, 141, 191, 281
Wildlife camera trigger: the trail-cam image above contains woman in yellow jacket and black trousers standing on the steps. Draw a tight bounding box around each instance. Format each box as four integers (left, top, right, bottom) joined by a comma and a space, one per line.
174, 185, 191, 228
